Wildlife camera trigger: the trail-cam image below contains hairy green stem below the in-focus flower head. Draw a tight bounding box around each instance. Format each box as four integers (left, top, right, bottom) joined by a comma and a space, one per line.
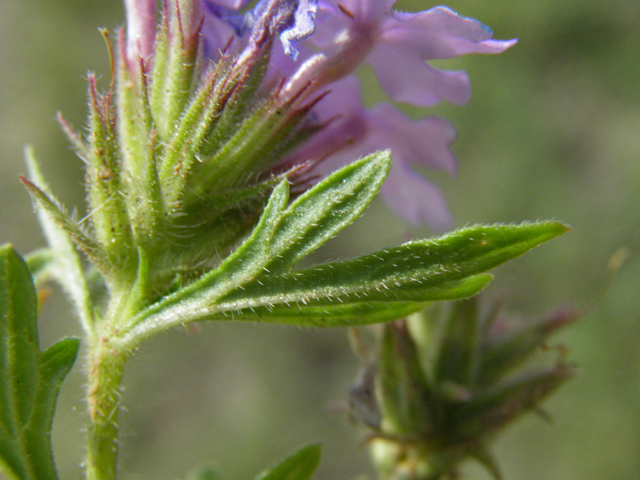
87, 332, 128, 480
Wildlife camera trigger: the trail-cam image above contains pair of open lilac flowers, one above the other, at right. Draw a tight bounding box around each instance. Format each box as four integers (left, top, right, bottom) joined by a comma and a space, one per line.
281, 0, 516, 230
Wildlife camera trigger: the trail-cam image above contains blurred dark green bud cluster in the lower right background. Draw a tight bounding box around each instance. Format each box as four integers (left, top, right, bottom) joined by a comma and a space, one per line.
350, 297, 578, 480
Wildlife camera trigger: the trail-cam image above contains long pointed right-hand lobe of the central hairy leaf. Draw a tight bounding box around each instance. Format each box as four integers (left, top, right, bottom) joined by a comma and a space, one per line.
206, 218, 567, 314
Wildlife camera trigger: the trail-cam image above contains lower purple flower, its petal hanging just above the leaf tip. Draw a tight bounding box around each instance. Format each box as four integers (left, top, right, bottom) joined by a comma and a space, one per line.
288, 76, 456, 230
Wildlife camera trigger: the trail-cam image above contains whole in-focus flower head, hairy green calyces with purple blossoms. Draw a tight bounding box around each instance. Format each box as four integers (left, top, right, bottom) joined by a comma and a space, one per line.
25, 0, 513, 308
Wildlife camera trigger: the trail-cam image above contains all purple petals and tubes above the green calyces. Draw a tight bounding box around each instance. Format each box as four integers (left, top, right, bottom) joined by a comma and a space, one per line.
126, 0, 515, 229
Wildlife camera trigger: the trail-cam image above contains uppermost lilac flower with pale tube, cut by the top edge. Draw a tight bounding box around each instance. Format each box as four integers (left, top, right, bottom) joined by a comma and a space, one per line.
287, 0, 516, 107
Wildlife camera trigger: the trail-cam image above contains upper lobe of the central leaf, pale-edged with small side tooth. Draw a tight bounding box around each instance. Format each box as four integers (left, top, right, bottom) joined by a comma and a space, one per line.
118, 152, 390, 342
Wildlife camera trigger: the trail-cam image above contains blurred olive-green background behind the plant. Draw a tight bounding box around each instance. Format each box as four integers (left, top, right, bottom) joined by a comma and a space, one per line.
0, 0, 640, 480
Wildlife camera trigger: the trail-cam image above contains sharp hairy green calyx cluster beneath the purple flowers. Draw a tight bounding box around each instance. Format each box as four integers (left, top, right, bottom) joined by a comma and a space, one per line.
23, 7, 320, 312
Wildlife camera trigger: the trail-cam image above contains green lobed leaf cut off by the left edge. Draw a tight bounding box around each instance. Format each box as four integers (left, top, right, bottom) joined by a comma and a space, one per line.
0, 246, 80, 480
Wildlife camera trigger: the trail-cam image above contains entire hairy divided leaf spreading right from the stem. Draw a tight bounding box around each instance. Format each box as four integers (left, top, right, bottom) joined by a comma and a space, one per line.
121, 153, 568, 346
